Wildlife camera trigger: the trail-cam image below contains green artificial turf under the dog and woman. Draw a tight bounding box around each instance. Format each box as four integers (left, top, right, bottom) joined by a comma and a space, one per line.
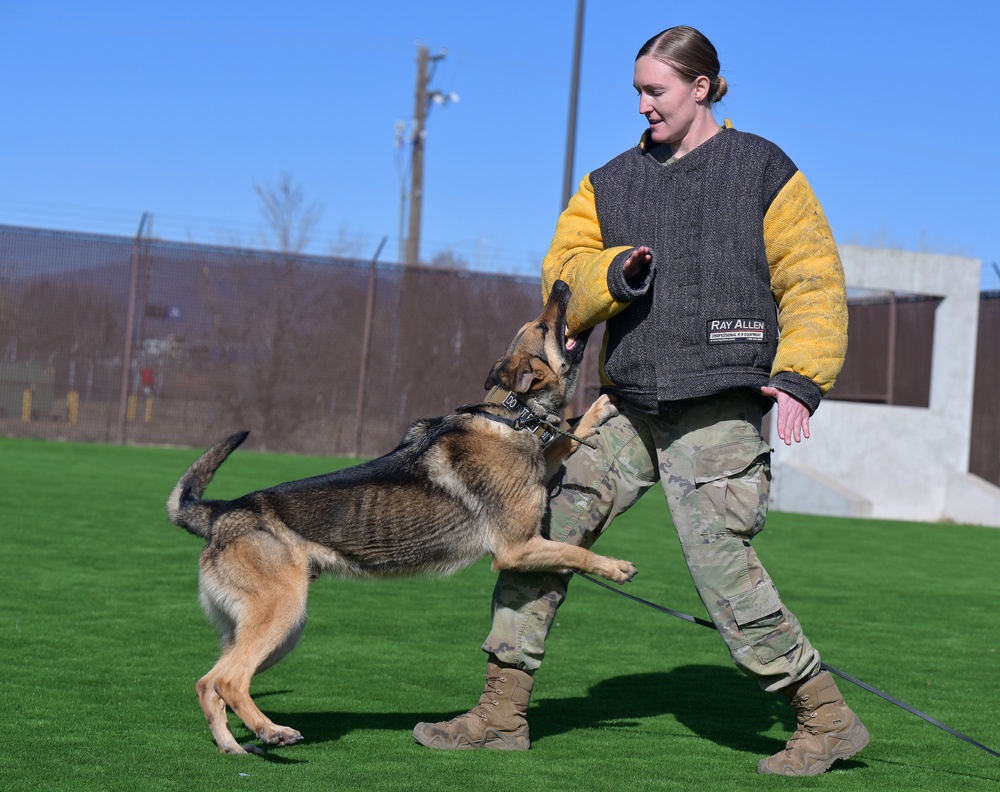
0, 439, 1000, 792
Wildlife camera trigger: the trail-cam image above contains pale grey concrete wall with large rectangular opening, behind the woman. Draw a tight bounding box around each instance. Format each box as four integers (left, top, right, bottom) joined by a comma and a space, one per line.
771, 246, 1000, 526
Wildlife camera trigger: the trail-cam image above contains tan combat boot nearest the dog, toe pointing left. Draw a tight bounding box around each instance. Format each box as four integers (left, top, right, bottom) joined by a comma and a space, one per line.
413, 655, 534, 751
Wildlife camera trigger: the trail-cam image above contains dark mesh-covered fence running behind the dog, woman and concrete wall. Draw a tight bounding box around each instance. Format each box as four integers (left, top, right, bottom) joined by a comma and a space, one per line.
0, 226, 1000, 484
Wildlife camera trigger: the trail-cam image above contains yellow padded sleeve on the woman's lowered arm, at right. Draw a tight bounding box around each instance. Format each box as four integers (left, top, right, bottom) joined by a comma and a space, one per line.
764, 171, 847, 394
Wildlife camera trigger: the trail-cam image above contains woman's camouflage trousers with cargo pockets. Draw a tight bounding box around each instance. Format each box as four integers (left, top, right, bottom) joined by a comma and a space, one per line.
483, 391, 820, 690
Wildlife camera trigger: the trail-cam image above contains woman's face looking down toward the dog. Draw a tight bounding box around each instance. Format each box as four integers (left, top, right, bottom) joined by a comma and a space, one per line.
634, 55, 710, 145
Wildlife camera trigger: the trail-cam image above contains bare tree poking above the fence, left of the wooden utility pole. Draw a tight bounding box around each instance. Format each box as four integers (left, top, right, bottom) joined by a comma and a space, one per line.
192, 173, 363, 449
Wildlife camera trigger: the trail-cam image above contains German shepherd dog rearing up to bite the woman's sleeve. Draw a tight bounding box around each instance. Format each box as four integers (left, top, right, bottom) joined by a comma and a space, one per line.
167, 281, 636, 753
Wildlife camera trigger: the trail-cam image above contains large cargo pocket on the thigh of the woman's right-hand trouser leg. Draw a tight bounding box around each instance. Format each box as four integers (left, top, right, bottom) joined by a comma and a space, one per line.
694, 435, 771, 539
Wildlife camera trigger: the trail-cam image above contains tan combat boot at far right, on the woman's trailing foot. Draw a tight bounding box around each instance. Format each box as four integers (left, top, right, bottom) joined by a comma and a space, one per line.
757, 671, 868, 776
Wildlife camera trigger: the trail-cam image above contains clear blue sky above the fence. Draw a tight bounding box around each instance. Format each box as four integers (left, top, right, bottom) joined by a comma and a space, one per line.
0, 0, 1000, 289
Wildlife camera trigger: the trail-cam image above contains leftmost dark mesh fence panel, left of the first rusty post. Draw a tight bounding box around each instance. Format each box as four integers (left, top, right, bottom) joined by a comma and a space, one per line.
0, 228, 134, 441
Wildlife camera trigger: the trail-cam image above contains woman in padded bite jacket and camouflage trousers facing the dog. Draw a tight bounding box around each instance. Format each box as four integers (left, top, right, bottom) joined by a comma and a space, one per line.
414, 27, 868, 775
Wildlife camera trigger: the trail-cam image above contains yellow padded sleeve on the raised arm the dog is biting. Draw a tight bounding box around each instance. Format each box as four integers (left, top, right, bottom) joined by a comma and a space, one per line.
542, 174, 631, 335
